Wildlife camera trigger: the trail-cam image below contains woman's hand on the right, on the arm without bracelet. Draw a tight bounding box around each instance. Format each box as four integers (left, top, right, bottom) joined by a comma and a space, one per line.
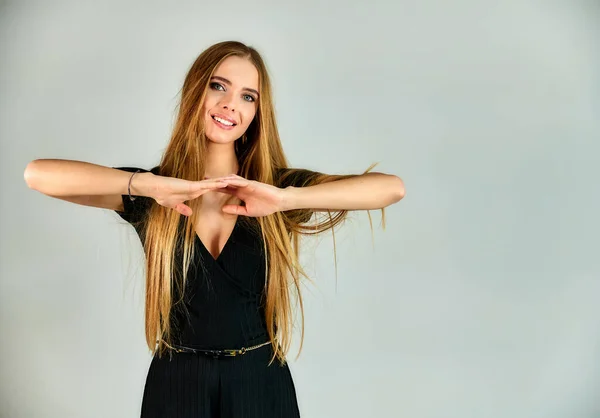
215, 174, 285, 217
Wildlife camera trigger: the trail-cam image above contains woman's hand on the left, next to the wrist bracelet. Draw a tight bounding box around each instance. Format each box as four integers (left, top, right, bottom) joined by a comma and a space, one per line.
148, 174, 227, 216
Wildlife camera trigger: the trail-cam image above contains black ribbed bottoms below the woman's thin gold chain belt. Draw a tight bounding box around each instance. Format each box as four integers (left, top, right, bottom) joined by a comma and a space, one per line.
141, 345, 300, 418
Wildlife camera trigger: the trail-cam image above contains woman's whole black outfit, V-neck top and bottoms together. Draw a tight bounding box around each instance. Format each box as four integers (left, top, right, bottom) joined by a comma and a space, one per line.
115, 167, 300, 418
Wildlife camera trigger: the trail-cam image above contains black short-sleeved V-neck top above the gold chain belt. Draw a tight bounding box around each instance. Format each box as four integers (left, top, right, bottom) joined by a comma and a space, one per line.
115, 167, 269, 349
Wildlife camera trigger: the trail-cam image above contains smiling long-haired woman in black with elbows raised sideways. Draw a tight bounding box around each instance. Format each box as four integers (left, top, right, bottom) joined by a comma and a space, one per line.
25, 42, 404, 418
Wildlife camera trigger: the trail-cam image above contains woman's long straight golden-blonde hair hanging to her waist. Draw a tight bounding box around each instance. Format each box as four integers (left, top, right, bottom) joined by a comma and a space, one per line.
134, 41, 385, 364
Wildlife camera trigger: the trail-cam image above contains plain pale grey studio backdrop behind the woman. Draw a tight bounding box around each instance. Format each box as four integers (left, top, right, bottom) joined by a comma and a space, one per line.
0, 0, 600, 418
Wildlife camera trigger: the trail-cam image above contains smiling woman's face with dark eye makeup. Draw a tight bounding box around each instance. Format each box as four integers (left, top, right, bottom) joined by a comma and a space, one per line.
202, 57, 259, 144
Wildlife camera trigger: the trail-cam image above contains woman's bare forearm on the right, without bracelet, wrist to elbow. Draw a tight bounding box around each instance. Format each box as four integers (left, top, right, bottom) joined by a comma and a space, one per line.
282, 172, 405, 211
